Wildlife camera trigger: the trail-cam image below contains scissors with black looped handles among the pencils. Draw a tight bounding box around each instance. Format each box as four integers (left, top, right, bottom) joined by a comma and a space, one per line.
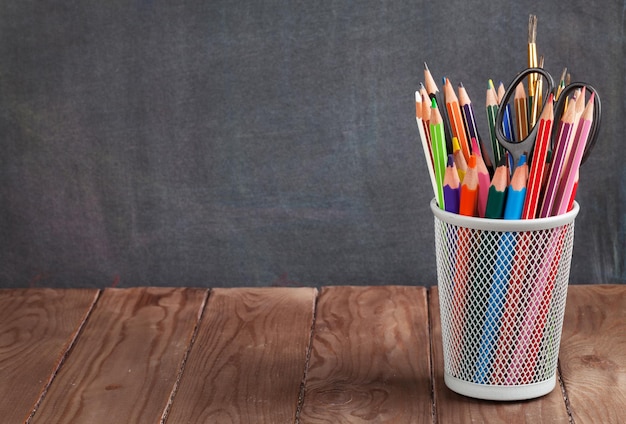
495, 68, 602, 167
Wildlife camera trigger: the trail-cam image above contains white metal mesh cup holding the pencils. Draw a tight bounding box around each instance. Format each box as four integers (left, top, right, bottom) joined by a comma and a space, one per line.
430, 199, 579, 400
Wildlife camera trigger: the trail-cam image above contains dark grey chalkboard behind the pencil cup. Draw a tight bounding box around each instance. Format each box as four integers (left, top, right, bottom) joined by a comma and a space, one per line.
0, 0, 626, 287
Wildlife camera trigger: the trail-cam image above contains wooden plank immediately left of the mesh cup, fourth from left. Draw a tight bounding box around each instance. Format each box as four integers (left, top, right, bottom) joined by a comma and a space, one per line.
299, 286, 432, 424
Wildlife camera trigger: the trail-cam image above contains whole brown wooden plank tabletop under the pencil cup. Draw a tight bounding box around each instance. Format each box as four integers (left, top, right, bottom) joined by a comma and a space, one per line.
0, 285, 626, 424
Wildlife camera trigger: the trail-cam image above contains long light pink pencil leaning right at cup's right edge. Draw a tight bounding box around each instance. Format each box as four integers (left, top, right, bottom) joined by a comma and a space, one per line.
553, 93, 595, 215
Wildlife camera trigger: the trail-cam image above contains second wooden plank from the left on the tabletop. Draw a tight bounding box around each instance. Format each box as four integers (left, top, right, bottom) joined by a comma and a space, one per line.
33, 287, 207, 424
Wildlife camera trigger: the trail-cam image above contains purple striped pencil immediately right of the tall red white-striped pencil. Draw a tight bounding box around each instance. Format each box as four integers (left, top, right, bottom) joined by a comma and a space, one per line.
539, 89, 584, 218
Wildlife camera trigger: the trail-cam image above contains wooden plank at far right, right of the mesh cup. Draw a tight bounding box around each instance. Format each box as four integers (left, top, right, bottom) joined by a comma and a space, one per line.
559, 285, 626, 423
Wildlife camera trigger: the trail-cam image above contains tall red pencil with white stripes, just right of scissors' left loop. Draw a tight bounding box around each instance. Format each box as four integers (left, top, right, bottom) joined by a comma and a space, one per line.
522, 93, 554, 219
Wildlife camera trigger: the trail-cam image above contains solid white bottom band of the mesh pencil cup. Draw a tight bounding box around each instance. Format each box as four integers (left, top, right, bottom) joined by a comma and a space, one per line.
444, 373, 556, 401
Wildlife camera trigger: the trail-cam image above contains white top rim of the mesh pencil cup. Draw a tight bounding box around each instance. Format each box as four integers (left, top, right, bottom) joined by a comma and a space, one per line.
430, 198, 580, 231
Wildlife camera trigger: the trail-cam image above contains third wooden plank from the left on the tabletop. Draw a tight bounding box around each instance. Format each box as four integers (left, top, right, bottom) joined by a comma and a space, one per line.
167, 288, 317, 423
